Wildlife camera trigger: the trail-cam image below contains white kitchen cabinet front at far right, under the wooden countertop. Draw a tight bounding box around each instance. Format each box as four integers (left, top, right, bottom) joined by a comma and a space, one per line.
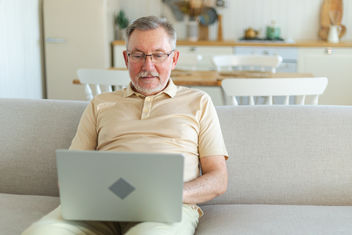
298, 47, 352, 105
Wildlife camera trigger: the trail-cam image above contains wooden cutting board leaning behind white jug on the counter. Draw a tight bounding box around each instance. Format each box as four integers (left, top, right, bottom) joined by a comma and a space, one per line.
319, 0, 346, 41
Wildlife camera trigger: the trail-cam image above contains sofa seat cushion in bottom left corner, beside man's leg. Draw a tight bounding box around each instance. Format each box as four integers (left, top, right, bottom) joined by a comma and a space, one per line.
0, 193, 60, 235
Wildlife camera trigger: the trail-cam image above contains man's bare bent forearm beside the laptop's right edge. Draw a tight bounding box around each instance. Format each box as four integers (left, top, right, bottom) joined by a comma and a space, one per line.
183, 156, 227, 204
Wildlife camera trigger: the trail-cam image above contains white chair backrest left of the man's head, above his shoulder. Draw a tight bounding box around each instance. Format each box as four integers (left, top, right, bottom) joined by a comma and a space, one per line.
77, 69, 131, 100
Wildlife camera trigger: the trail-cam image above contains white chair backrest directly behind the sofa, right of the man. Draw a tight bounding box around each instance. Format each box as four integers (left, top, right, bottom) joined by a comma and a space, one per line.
221, 77, 328, 105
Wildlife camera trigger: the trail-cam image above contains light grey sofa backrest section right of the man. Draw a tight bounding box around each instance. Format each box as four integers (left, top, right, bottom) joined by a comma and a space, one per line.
208, 106, 352, 205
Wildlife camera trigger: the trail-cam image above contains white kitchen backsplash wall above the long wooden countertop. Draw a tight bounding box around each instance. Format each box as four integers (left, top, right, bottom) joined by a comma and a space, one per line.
120, 0, 352, 41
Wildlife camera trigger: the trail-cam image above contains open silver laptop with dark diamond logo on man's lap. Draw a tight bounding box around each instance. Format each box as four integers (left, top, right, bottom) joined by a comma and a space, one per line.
56, 149, 184, 222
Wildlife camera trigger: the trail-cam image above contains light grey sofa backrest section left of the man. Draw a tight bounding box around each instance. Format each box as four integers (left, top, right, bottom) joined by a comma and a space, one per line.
0, 99, 87, 196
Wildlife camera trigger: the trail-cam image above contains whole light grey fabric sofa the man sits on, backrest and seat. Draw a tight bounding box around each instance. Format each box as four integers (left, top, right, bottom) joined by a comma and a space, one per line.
0, 99, 352, 235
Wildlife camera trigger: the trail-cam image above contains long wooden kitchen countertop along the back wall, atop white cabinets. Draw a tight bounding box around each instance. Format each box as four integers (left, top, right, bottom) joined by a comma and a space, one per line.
112, 40, 352, 48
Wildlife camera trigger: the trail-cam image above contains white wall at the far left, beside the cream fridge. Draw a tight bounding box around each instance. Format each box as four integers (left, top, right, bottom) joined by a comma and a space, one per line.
0, 0, 43, 98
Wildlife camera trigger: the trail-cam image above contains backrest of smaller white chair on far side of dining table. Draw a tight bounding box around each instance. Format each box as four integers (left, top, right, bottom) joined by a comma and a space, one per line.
213, 55, 282, 73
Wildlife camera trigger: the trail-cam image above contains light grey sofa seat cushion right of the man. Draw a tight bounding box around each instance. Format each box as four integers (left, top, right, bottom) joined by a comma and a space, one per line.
196, 204, 352, 235
